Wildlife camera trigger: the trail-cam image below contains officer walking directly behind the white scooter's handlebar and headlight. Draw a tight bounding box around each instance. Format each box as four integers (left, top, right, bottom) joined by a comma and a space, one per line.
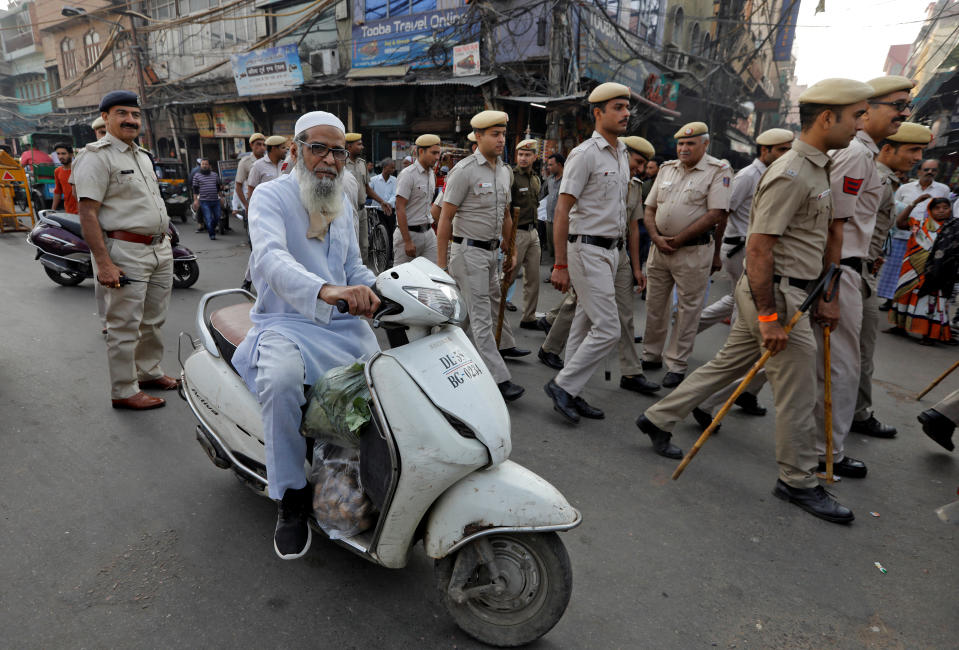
436, 111, 529, 401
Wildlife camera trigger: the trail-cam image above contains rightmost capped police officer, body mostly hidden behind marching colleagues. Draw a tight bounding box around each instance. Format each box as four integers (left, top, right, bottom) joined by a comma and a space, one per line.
852, 122, 932, 435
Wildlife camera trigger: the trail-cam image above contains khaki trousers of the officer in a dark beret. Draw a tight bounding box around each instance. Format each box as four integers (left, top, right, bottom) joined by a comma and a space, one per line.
94, 239, 173, 399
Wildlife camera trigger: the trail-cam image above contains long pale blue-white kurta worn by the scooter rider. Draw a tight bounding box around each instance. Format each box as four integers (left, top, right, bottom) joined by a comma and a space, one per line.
233, 174, 379, 392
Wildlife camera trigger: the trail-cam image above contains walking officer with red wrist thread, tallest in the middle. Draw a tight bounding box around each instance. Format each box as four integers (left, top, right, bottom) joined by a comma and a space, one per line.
545, 83, 630, 422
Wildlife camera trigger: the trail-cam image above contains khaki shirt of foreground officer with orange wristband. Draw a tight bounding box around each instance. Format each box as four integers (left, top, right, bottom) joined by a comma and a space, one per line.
752, 140, 832, 280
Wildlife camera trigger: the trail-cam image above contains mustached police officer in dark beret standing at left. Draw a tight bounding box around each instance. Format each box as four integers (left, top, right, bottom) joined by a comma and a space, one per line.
73, 90, 179, 410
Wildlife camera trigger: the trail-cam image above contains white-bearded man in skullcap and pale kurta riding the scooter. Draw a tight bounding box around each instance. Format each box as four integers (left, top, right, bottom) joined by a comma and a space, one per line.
233, 111, 380, 560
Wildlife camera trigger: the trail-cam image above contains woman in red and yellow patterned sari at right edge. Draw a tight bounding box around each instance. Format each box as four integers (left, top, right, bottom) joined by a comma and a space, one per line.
889, 198, 957, 345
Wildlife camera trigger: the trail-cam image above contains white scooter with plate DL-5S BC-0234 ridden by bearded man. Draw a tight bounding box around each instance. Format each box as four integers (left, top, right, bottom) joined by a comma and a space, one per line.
180, 258, 581, 646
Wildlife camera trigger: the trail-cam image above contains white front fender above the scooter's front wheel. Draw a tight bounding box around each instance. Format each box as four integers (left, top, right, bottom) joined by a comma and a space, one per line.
423, 460, 582, 558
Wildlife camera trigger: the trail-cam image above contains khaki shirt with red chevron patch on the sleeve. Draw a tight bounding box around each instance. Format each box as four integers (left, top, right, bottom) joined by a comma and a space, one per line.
829, 131, 882, 258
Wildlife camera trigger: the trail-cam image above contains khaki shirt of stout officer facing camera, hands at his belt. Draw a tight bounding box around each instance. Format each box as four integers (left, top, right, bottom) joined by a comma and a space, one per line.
646, 154, 733, 237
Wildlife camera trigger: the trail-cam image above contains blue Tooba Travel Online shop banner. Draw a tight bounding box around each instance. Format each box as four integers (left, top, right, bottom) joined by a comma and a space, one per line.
353, 7, 470, 68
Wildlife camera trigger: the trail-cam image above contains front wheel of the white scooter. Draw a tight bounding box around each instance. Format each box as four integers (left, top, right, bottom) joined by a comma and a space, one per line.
435, 533, 573, 647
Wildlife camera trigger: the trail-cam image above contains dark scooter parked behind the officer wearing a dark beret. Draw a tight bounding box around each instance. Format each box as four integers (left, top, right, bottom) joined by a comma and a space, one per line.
27, 210, 200, 289
